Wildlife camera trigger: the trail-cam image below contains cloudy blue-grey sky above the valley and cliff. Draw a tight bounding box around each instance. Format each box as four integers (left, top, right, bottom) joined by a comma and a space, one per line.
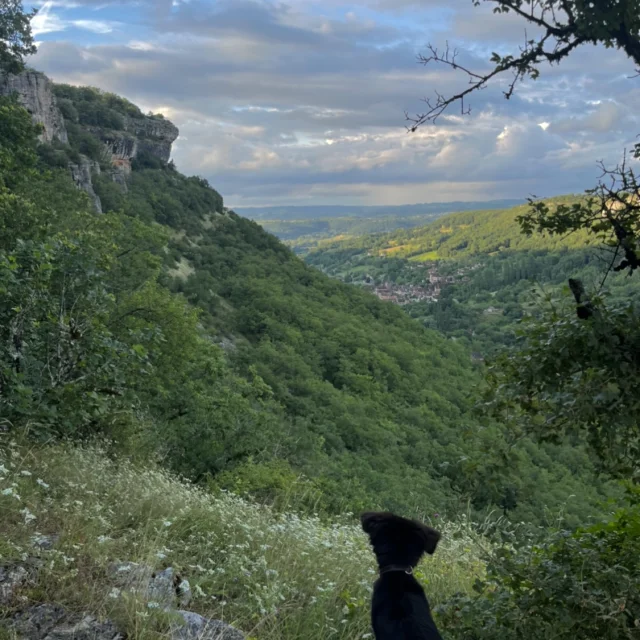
25, 0, 640, 207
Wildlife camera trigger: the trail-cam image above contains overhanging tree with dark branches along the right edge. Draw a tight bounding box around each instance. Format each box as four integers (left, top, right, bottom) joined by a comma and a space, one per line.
407, 0, 640, 479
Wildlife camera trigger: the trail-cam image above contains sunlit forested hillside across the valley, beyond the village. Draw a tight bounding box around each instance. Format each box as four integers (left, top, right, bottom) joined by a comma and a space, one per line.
306, 196, 640, 357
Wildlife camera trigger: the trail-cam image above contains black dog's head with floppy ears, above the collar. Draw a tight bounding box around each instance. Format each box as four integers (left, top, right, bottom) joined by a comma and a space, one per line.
360, 513, 440, 567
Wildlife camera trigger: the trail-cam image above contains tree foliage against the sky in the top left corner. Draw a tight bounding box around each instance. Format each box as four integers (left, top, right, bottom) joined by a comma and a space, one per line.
0, 0, 36, 73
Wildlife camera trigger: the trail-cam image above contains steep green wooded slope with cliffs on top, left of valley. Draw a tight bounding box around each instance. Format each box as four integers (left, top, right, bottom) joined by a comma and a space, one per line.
0, 65, 614, 524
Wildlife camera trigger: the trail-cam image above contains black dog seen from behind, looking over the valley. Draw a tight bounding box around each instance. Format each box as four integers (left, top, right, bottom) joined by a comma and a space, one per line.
360, 513, 442, 640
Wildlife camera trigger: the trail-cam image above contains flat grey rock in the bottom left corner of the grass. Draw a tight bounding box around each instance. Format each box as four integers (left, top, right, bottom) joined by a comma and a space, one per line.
8, 604, 124, 640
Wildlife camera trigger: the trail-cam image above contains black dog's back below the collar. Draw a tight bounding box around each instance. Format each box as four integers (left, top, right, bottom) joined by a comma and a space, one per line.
371, 571, 442, 640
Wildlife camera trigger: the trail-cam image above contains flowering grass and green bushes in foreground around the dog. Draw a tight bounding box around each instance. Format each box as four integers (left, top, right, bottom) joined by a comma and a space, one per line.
0, 440, 640, 640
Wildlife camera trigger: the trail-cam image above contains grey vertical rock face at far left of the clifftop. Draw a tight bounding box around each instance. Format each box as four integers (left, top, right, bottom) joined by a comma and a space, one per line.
0, 69, 69, 144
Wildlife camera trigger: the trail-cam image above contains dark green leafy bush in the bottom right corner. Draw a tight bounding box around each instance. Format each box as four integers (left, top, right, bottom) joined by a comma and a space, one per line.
440, 493, 640, 640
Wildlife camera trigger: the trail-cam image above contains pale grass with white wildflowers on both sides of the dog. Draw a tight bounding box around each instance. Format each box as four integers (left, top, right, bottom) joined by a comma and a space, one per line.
0, 435, 484, 640
